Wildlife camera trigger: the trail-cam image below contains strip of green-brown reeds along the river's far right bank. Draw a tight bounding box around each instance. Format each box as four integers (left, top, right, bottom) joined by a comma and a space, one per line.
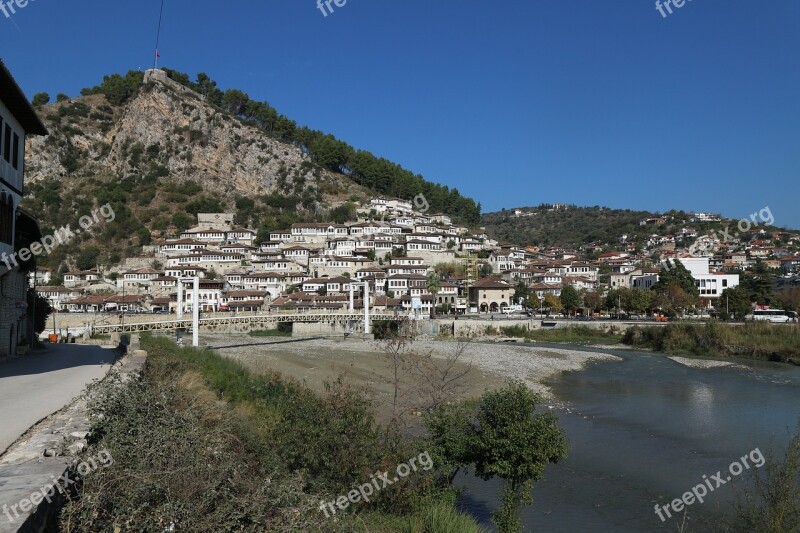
623, 322, 800, 364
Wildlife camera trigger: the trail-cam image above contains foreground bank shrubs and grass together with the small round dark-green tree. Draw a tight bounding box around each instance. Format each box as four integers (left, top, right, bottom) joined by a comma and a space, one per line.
61, 336, 566, 533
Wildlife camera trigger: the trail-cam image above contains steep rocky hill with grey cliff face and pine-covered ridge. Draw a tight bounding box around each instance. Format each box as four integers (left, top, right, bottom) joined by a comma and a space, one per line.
24, 69, 480, 270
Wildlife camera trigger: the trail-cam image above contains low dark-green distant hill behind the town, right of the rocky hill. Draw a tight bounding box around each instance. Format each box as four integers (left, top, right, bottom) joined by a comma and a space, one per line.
481, 204, 668, 248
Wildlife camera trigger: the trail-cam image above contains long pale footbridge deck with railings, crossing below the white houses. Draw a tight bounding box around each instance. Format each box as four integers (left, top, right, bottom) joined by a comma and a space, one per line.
91, 312, 403, 335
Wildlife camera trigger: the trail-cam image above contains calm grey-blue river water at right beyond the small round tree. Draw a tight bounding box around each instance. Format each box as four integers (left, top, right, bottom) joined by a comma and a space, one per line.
457, 343, 800, 532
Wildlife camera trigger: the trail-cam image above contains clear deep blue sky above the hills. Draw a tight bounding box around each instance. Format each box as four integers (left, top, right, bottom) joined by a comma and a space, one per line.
0, 0, 800, 228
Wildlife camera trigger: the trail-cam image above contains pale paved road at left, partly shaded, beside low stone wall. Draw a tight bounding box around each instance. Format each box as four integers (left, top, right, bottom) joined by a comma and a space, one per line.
0, 344, 117, 453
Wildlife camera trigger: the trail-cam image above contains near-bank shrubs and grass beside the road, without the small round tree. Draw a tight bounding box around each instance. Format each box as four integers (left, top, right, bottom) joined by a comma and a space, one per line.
61, 337, 481, 533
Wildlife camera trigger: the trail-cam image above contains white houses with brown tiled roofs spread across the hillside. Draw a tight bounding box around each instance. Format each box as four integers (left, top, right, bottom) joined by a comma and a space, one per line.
31, 196, 800, 316
